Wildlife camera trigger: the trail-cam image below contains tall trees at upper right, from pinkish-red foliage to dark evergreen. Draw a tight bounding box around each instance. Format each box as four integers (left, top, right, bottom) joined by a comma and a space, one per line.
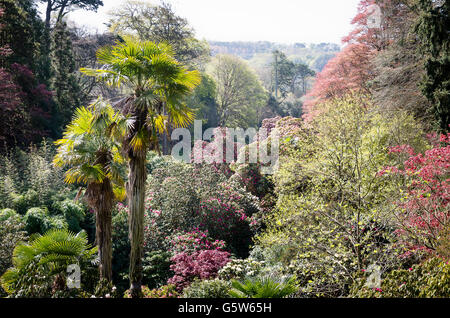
304, 0, 450, 132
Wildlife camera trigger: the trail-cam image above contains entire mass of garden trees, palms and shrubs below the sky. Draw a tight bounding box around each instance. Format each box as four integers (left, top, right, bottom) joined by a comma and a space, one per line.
0, 0, 450, 298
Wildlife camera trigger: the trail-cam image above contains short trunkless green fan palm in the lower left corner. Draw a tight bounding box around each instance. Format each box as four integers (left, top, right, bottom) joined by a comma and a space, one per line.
1, 230, 97, 297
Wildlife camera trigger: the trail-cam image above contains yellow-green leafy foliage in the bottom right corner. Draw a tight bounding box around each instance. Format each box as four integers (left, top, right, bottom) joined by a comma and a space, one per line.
350, 257, 450, 298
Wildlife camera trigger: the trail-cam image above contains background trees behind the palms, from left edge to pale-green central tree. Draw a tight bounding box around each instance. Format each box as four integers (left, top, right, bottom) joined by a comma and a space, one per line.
0, 0, 316, 154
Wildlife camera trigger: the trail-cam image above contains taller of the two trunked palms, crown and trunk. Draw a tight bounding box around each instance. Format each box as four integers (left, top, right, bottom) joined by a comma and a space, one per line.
81, 37, 200, 297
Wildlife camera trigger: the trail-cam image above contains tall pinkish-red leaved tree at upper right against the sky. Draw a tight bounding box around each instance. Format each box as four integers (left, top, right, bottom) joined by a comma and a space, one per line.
303, 0, 410, 121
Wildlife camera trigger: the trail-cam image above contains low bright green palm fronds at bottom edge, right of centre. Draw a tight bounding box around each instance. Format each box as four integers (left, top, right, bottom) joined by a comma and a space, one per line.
229, 276, 298, 298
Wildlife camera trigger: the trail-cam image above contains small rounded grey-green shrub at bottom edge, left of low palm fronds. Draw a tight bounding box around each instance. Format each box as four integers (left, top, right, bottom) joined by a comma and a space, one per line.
183, 279, 231, 298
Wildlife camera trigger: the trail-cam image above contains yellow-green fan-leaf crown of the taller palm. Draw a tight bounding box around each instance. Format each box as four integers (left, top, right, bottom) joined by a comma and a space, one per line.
81, 37, 200, 146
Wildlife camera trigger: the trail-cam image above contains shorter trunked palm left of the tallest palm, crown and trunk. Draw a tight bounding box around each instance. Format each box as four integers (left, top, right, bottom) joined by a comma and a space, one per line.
53, 99, 127, 281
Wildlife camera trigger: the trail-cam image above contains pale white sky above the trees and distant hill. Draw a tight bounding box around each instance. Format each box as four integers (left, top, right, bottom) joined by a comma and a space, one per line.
39, 0, 360, 44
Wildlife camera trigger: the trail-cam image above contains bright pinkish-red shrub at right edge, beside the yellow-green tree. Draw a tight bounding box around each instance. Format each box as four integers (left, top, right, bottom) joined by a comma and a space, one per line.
379, 134, 450, 251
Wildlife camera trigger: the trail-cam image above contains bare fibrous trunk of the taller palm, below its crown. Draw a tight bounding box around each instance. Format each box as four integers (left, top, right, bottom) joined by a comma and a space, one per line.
127, 154, 147, 298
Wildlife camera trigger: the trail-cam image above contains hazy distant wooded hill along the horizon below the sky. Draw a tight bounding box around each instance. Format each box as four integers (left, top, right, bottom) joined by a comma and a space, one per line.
209, 41, 341, 72
